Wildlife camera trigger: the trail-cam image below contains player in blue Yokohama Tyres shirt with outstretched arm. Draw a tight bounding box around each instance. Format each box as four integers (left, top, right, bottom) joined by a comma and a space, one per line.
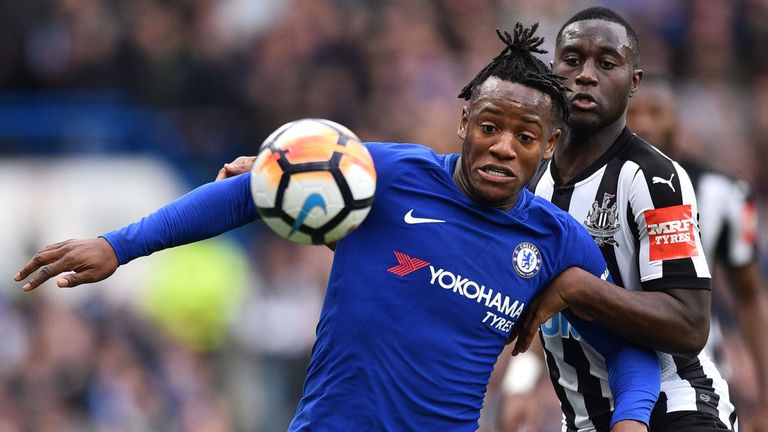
14, 25, 660, 432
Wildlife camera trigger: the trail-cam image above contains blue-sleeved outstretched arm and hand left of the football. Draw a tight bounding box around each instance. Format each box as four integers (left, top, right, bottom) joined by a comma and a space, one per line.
13, 175, 258, 291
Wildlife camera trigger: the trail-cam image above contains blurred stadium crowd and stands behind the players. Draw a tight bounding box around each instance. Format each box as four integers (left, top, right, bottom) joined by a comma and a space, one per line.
0, 0, 768, 432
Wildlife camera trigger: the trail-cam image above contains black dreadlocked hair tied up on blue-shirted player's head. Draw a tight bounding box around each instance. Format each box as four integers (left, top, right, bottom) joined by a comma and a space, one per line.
459, 22, 570, 122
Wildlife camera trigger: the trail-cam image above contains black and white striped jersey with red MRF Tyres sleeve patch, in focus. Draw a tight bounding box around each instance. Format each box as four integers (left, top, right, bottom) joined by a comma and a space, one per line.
529, 128, 734, 432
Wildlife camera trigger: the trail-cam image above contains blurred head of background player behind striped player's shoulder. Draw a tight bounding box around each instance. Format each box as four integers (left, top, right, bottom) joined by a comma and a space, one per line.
627, 84, 676, 154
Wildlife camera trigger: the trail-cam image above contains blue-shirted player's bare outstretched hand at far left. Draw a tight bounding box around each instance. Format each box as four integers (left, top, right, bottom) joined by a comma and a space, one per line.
13, 238, 119, 291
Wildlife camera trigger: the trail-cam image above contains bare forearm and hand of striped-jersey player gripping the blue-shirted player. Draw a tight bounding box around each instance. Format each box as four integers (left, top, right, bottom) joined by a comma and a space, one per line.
513, 267, 710, 355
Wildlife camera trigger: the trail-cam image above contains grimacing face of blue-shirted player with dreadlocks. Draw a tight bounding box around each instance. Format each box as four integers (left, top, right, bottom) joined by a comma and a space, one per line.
455, 77, 560, 210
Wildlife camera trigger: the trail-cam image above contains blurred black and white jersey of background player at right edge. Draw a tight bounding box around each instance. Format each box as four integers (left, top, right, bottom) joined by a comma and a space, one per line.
680, 161, 757, 362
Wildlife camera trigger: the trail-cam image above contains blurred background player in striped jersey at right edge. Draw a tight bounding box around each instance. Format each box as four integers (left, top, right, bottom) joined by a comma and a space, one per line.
627, 76, 768, 432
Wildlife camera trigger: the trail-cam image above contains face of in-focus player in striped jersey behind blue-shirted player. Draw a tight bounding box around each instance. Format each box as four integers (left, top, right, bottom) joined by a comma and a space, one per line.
552, 19, 642, 131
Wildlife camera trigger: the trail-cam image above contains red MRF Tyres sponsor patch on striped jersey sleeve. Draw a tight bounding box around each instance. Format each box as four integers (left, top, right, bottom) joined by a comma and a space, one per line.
643, 204, 699, 261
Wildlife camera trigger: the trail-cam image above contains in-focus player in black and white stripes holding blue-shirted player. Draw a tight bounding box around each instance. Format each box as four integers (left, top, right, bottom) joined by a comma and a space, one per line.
504, 7, 736, 432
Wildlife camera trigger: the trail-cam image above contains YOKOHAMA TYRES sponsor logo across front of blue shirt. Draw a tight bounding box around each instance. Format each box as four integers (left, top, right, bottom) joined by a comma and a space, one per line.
387, 250, 524, 333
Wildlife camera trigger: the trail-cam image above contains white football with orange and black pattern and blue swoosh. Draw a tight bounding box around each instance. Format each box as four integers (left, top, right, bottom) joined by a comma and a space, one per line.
251, 119, 376, 244
